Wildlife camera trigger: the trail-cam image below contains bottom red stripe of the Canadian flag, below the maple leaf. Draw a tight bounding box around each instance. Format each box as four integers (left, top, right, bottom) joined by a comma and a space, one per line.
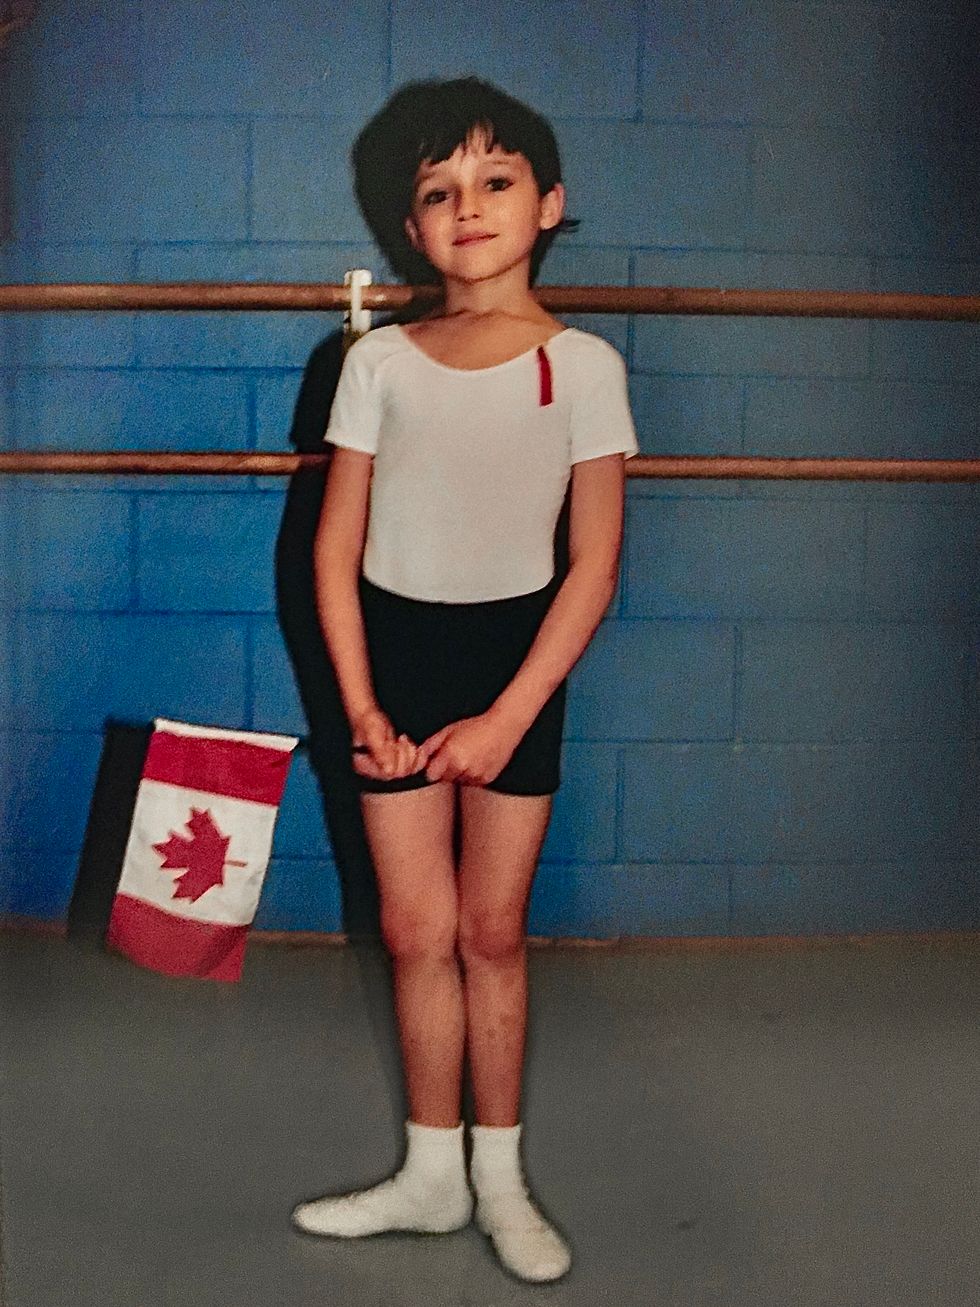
106, 894, 248, 980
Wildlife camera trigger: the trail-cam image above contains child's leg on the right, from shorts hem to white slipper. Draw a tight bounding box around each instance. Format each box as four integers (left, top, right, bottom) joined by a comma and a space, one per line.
460, 786, 571, 1281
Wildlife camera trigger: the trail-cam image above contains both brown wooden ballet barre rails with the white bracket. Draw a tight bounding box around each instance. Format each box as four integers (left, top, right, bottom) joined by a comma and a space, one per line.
0, 278, 980, 482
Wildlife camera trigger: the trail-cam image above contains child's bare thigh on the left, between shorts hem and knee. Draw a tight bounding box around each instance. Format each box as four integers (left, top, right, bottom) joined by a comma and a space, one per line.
361, 780, 456, 929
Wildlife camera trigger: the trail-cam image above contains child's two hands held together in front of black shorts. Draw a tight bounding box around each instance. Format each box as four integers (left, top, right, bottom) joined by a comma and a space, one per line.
353, 708, 524, 786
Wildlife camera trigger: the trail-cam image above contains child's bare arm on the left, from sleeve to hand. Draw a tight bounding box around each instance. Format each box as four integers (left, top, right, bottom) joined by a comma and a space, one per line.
314, 447, 416, 776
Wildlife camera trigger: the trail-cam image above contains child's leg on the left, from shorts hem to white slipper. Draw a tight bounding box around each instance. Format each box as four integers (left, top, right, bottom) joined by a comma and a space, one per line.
293, 783, 473, 1238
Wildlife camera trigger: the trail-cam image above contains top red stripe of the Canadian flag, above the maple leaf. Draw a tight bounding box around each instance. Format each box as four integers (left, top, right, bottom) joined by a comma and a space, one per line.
142, 729, 290, 806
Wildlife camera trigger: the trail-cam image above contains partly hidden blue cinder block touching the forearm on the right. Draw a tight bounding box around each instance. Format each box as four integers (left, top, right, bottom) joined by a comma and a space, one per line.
566, 620, 734, 740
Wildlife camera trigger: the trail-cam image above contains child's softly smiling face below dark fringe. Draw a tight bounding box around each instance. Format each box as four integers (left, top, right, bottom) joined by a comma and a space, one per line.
405, 126, 564, 281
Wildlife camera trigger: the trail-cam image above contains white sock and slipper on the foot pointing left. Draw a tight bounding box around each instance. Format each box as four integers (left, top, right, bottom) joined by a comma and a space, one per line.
293, 1121, 473, 1239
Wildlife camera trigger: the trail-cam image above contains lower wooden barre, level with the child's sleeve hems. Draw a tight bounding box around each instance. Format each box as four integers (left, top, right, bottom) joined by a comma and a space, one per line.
0, 450, 980, 481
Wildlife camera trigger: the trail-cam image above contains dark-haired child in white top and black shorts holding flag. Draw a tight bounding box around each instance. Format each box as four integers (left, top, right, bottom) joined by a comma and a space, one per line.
293, 78, 638, 1281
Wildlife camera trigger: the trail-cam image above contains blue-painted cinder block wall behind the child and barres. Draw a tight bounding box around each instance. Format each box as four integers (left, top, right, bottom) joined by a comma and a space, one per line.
0, 0, 980, 936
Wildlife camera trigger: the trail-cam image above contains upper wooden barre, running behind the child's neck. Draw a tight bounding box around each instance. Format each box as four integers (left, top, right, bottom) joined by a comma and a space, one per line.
0, 281, 980, 322
